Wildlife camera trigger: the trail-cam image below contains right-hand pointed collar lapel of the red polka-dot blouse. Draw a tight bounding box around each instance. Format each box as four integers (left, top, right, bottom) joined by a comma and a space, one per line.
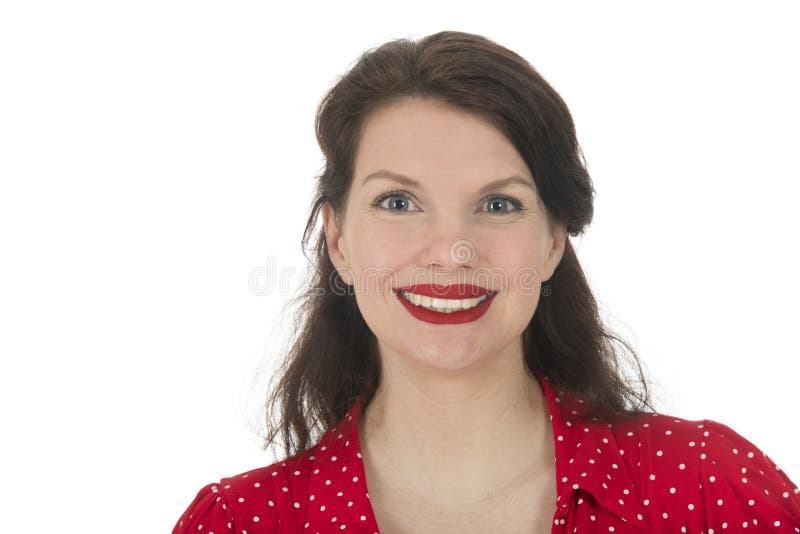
534, 372, 651, 530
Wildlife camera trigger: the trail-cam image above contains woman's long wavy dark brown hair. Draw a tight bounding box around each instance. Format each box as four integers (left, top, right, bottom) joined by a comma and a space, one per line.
264, 31, 655, 462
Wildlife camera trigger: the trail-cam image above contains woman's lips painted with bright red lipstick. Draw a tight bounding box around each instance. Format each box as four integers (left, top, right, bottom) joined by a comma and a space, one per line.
395, 284, 496, 324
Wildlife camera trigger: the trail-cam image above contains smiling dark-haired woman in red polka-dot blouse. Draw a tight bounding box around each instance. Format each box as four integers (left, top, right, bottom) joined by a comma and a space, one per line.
173, 32, 800, 534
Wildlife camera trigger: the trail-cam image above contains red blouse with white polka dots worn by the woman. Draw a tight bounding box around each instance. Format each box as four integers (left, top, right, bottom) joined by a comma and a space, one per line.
172, 374, 800, 534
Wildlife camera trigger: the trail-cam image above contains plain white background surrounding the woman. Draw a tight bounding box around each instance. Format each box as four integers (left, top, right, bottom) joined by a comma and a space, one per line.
0, 0, 800, 533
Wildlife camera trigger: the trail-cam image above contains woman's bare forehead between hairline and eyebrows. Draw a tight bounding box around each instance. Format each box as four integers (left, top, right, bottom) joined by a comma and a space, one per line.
354, 98, 530, 184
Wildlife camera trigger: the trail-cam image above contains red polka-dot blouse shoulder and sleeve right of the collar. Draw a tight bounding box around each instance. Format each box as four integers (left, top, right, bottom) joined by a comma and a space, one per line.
613, 414, 800, 532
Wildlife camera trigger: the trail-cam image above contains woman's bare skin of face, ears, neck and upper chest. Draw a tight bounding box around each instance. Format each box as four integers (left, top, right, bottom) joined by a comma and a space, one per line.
323, 97, 566, 531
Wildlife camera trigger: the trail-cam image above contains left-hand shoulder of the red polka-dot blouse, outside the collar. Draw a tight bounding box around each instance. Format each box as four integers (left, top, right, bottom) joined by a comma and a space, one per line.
172, 446, 317, 534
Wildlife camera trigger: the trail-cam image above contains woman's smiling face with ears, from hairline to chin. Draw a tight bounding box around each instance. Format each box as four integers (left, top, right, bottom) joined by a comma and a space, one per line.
323, 98, 566, 371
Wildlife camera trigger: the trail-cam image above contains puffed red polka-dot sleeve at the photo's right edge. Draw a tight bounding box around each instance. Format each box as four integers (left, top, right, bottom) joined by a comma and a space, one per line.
700, 419, 800, 533
